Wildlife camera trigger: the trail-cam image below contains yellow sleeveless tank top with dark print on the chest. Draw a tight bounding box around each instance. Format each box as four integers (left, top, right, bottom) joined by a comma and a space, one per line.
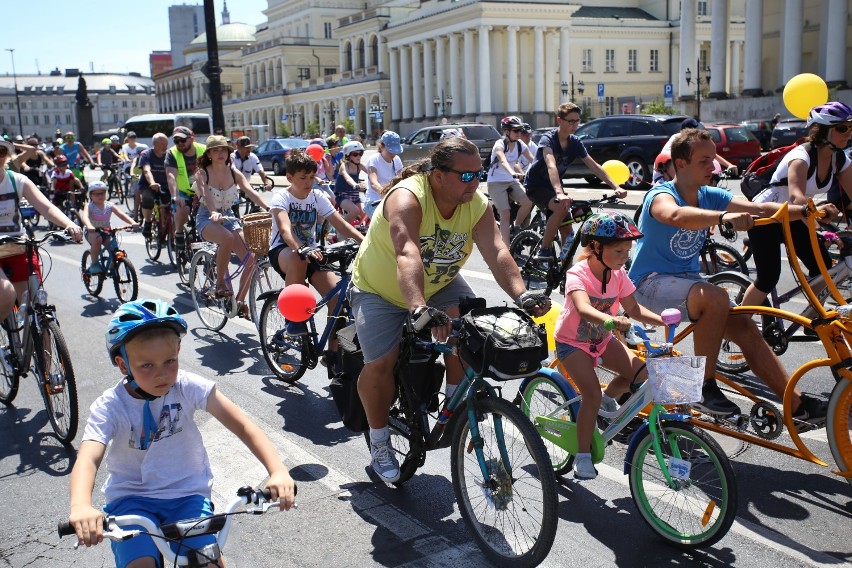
352, 174, 488, 308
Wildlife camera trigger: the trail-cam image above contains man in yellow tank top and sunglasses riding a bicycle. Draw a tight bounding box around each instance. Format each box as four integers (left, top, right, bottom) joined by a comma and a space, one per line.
350, 138, 550, 483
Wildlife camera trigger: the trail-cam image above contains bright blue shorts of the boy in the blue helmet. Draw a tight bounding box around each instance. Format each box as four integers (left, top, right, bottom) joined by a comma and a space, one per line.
104, 495, 216, 568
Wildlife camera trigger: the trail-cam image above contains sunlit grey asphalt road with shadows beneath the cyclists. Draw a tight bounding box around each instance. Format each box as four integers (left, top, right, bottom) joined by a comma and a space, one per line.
0, 175, 852, 568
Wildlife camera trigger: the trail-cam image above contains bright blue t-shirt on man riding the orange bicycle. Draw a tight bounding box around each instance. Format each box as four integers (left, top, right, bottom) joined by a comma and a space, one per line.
628, 181, 732, 286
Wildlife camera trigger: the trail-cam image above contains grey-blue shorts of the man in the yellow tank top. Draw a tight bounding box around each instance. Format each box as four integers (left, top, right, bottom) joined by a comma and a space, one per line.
349, 276, 474, 363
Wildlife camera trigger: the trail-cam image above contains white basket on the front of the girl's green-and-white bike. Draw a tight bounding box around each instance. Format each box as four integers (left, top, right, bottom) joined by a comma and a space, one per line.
645, 356, 707, 404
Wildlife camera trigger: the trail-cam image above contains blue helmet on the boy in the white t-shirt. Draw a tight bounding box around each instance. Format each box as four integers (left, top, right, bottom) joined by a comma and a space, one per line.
104, 300, 187, 365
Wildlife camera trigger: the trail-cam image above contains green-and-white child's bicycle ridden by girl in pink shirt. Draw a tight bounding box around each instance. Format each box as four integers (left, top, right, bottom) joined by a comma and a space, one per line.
516, 310, 738, 548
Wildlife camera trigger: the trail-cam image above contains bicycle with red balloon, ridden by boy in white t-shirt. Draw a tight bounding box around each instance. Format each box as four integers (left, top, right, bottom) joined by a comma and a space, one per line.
258, 239, 360, 384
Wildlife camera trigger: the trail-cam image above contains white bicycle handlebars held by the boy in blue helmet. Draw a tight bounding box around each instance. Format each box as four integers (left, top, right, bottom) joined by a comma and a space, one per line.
57, 485, 295, 568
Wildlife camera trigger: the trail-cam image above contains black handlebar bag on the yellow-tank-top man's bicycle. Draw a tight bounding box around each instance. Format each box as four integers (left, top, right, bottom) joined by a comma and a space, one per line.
459, 306, 547, 381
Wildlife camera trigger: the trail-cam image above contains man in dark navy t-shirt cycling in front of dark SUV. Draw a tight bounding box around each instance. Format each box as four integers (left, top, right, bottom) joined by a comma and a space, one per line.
524, 103, 627, 261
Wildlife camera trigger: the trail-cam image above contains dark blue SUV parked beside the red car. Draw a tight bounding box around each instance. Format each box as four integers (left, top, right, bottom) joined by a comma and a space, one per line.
565, 114, 689, 189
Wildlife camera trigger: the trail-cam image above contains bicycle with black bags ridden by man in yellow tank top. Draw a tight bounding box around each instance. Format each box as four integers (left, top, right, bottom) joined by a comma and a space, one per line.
368, 299, 558, 567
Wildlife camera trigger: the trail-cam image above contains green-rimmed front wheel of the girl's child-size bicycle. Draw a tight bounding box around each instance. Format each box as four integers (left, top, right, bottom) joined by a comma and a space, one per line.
628, 421, 738, 549
